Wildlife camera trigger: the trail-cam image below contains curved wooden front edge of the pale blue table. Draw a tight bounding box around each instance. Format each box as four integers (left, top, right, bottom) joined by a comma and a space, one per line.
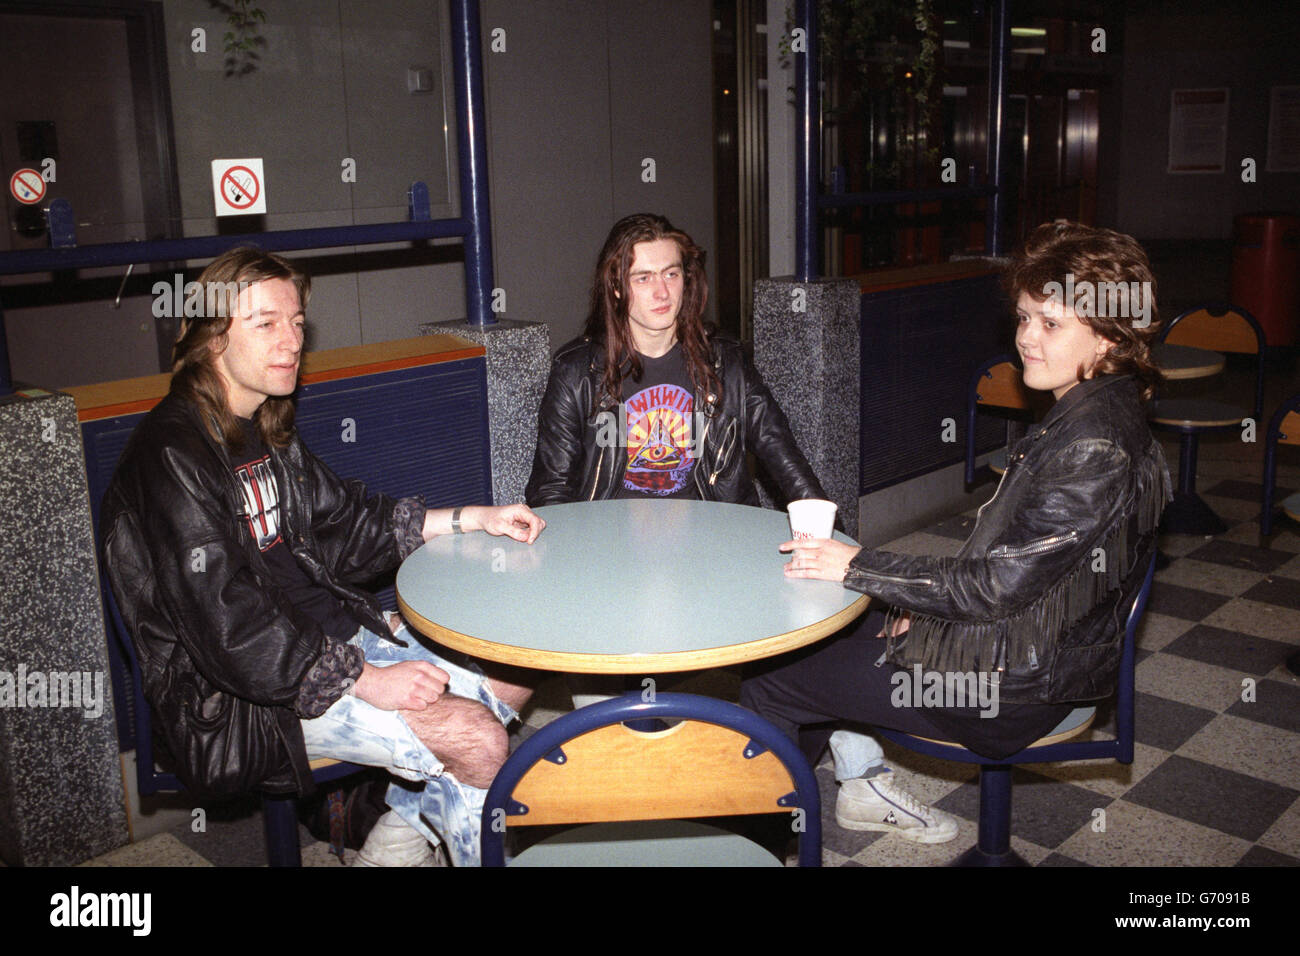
397, 592, 871, 674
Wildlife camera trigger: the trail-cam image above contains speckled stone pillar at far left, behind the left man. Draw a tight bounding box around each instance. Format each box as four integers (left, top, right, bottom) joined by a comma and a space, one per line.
0, 390, 127, 866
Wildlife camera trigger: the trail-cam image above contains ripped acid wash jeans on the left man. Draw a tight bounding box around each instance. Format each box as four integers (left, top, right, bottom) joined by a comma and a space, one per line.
302, 623, 517, 866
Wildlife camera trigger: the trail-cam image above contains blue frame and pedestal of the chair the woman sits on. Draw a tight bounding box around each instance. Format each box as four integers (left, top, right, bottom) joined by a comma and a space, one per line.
875, 555, 1156, 866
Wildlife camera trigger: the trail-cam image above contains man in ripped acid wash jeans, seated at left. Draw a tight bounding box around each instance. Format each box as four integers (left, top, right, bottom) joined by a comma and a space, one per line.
103, 248, 545, 865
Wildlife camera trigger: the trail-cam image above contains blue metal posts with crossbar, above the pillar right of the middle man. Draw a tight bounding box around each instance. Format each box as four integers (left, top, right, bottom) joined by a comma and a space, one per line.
794, 0, 1008, 282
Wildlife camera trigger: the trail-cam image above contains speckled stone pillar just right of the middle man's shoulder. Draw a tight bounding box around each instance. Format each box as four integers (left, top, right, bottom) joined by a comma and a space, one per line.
754, 278, 862, 537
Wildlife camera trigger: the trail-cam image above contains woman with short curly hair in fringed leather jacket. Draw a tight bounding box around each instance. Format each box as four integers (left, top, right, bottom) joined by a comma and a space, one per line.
741, 221, 1170, 843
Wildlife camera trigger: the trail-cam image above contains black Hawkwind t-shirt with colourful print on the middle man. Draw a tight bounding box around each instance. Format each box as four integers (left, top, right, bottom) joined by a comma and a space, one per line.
616, 345, 699, 498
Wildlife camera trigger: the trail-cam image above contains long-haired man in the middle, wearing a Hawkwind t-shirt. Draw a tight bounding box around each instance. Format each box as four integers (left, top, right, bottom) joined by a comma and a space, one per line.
527, 213, 826, 507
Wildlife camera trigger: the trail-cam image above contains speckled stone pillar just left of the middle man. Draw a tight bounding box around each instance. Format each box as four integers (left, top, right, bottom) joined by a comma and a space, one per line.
420, 319, 551, 505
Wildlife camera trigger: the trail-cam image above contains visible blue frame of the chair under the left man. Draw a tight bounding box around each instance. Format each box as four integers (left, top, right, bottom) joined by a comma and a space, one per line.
100, 574, 365, 866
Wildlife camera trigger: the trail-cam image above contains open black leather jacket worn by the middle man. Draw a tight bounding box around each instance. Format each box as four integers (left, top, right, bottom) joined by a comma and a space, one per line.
525, 337, 826, 507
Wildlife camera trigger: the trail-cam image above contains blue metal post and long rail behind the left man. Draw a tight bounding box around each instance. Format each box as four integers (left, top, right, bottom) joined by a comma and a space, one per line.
0, 0, 497, 395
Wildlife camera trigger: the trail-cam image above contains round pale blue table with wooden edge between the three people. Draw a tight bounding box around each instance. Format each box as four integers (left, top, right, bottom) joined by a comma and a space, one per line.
397, 499, 868, 674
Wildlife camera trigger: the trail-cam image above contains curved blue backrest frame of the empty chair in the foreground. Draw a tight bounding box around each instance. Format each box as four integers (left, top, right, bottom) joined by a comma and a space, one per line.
482, 693, 822, 866
